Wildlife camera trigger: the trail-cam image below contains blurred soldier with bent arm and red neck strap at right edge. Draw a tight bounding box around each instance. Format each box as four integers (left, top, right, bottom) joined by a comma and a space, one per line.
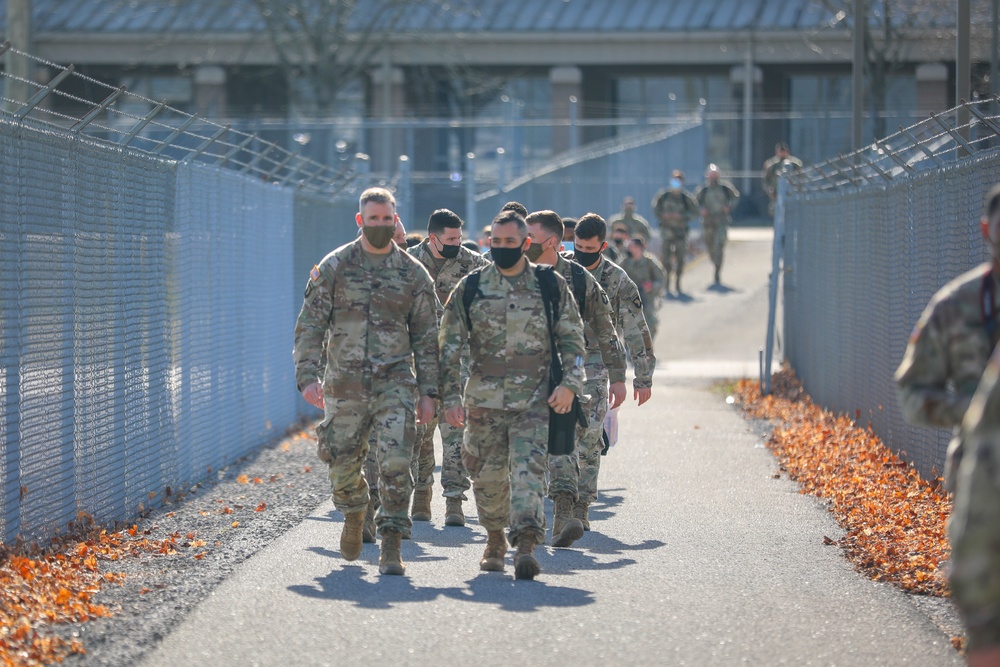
896, 185, 1000, 489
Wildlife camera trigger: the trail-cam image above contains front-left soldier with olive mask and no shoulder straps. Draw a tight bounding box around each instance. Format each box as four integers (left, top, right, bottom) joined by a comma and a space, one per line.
294, 188, 440, 574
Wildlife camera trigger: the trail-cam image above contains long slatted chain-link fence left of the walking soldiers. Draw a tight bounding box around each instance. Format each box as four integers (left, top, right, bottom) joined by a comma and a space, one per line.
0, 49, 356, 542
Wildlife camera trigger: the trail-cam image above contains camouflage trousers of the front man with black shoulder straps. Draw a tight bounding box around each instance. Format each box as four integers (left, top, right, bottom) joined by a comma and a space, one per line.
462, 401, 549, 544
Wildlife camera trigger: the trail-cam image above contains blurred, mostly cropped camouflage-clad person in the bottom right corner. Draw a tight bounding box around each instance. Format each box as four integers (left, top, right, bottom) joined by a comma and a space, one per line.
948, 348, 1000, 665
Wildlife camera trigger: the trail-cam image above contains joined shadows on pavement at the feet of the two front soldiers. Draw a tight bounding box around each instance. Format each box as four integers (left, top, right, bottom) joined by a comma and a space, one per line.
288, 565, 595, 612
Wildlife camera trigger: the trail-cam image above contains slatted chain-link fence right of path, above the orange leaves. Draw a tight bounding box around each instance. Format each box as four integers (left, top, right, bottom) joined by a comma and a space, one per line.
783, 103, 1000, 478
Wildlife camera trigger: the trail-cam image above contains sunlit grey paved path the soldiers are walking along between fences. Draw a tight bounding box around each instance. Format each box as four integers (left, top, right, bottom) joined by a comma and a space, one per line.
144, 232, 962, 667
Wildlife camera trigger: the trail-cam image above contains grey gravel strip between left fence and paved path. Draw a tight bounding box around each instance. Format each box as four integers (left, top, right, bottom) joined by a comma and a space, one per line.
56, 422, 330, 665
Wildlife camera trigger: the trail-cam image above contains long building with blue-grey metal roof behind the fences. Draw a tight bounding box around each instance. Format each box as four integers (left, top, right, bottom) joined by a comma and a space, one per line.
5, 0, 989, 216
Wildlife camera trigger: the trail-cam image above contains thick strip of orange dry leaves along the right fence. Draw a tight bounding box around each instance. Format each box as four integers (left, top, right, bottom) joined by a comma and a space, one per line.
736, 370, 951, 596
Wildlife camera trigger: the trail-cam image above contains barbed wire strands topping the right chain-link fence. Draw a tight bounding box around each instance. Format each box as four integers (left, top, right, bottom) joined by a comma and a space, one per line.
784, 98, 1000, 194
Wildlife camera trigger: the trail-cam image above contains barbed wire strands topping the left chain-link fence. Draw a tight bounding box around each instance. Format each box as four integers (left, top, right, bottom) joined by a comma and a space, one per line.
0, 41, 368, 197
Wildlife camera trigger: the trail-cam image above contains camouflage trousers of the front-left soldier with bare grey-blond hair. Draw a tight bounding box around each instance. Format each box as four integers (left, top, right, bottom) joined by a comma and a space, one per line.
316, 385, 416, 534
